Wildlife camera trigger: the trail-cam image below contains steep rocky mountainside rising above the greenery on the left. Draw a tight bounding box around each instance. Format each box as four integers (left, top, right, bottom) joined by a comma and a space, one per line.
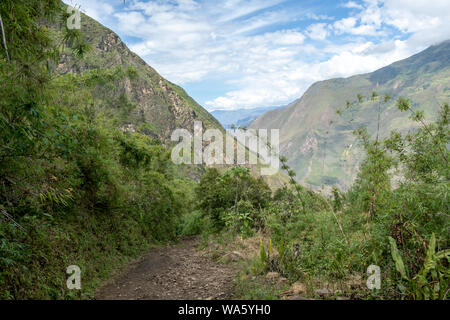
55, 14, 222, 142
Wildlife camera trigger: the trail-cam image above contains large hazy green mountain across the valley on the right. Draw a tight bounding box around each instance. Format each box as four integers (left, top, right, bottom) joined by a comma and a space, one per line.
250, 41, 450, 189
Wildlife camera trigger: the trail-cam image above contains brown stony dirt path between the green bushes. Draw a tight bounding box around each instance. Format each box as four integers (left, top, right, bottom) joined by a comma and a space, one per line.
95, 239, 236, 300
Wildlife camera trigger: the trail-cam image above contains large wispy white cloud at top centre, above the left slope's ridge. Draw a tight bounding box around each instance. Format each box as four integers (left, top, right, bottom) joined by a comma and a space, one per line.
120, 0, 305, 84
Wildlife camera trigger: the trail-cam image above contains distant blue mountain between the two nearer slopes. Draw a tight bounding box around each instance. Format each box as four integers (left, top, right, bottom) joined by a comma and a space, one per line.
211, 107, 279, 129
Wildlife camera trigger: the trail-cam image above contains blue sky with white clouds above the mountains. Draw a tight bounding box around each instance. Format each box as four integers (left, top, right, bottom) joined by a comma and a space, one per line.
64, 0, 450, 111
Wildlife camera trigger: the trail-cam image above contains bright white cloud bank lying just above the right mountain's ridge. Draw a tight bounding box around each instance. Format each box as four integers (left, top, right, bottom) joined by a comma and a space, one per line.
206, 40, 410, 109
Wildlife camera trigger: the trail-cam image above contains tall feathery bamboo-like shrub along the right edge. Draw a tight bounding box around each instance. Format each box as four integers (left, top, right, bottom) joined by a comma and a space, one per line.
340, 98, 450, 299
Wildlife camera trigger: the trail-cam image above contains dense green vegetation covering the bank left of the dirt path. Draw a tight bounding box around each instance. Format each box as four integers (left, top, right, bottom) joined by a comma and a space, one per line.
0, 0, 193, 299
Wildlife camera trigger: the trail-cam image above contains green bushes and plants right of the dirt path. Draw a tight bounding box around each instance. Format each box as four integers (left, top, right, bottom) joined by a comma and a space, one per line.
199, 93, 450, 299
